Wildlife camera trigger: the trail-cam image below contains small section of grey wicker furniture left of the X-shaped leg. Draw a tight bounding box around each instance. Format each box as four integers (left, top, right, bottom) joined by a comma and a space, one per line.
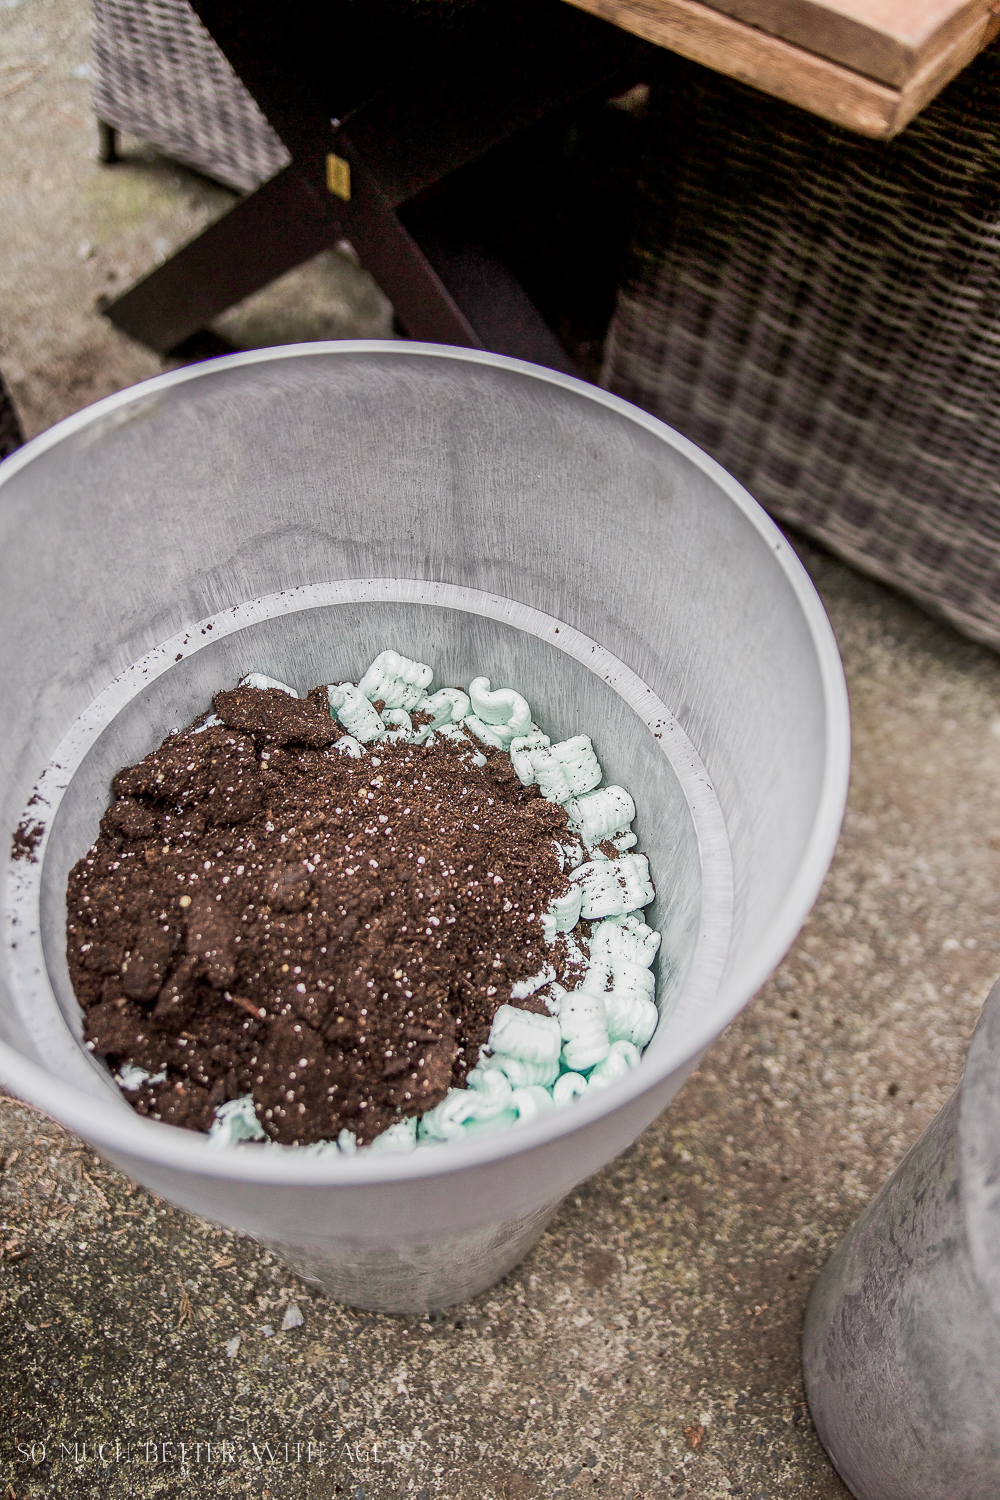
93, 0, 289, 191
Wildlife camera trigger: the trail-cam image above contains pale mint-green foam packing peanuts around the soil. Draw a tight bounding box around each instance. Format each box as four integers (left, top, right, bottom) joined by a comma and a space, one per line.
170, 651, 660, 1155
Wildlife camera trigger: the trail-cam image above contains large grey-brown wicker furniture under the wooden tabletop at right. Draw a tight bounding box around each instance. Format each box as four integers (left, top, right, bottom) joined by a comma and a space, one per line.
603, 48, 1000, 647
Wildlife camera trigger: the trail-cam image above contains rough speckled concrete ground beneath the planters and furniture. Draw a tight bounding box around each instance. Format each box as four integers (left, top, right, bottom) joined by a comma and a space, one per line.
0, 0, 1000, 1500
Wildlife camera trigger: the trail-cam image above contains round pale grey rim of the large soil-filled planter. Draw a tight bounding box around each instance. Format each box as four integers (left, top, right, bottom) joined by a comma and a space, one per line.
0, 339, 850, 1190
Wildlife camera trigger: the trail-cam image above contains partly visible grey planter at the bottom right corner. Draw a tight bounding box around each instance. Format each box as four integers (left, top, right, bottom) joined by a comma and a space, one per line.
802, 984, 1000, 1500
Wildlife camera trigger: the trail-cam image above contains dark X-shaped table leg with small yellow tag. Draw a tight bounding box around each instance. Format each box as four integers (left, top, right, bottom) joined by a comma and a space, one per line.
105, 0, 650, 369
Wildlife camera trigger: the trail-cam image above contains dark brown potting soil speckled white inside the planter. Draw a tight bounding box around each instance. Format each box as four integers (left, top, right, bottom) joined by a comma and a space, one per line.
67, 687, 580, 1145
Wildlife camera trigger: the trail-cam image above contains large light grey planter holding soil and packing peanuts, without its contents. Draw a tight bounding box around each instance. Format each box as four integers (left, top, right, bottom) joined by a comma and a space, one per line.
0, 342, 849, 1311
